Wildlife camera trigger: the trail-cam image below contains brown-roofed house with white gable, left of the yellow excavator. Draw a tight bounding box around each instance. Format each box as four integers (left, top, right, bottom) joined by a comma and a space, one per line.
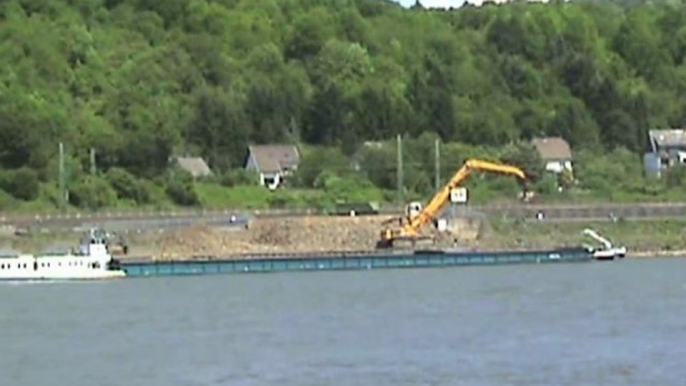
245, 145, 300, 189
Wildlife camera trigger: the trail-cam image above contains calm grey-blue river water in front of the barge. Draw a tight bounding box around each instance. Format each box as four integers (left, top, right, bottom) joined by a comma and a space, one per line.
0, 259, 686, 386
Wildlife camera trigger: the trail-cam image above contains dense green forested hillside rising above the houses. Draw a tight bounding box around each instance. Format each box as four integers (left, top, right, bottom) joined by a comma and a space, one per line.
0, 0, 686, 210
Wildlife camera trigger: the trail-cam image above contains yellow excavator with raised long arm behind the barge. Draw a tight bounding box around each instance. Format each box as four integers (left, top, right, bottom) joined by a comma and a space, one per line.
377, 159, 527, 248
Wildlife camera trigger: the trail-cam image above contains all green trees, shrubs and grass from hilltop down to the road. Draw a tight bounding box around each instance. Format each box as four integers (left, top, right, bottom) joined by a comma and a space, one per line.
0, 0, 686, 211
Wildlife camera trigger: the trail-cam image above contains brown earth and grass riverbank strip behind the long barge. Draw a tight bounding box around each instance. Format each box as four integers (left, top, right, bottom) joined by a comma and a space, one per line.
0, 216, 686, 260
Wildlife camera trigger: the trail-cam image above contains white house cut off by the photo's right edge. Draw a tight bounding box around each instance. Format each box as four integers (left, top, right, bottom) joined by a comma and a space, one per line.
643, 129, 686, 177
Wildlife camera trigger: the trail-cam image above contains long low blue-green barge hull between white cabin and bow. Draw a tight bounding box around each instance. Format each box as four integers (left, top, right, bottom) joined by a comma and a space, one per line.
121, 248, 593, 277
